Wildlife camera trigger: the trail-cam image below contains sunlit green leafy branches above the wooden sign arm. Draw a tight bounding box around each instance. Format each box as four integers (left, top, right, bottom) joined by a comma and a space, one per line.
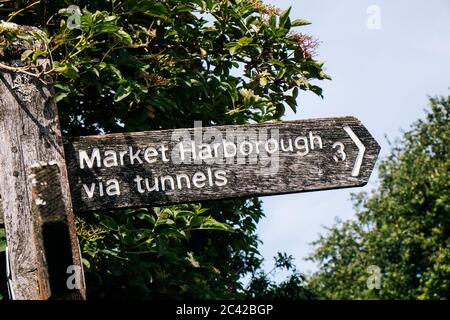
2, 0, 330, 132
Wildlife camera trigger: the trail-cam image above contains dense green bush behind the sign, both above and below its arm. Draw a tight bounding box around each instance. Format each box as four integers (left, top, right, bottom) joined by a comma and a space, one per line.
0, 0, 329, 299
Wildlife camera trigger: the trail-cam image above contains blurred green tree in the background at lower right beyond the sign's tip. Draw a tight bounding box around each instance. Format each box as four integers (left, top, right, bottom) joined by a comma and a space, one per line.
310, 97, 450, 299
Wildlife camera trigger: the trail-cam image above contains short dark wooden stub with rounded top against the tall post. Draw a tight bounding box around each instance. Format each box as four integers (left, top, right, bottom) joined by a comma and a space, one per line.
31, 164, 84, 300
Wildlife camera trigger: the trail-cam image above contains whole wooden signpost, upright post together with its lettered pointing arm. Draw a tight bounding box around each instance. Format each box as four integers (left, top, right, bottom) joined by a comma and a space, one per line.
0, 23, 380, 299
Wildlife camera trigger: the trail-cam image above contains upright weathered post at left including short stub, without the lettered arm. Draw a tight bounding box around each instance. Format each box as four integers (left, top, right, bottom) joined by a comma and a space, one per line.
0, 23, 85, 300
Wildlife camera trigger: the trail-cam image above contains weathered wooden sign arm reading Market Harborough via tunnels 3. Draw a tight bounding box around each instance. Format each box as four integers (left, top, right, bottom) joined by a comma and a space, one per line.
65, 117, 380, 211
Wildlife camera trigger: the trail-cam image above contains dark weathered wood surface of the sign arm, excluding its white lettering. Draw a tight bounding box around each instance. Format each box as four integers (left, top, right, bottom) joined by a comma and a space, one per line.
65, 117, 380, 211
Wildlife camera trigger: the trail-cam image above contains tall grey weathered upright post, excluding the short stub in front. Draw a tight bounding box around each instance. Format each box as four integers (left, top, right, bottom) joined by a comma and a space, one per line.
0, 23, 85, 300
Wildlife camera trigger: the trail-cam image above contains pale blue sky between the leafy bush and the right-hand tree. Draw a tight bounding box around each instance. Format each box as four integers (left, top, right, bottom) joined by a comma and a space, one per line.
258, 0, 450, 279
